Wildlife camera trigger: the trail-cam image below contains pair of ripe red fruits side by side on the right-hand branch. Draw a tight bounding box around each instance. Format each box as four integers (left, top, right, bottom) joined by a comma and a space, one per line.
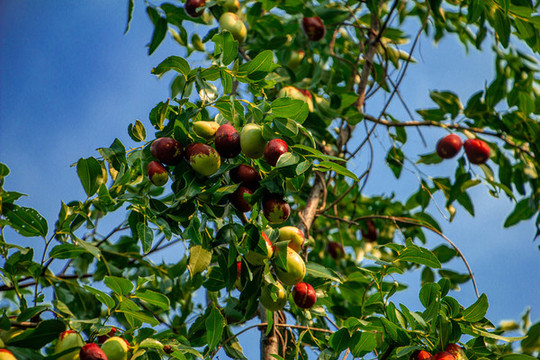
437, 134, 490, 165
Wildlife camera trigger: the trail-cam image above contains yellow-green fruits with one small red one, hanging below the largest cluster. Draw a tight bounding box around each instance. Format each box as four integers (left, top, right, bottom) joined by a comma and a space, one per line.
236, 226, 317, 311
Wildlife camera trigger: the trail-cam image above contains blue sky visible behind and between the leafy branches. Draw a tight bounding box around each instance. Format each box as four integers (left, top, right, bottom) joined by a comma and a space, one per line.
0, 0, 540, 358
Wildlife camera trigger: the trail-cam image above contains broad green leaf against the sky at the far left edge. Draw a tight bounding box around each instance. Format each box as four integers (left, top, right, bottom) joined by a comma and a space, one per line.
4, 206, 49, 237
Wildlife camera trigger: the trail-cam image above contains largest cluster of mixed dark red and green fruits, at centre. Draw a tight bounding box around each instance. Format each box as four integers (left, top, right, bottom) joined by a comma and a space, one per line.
147, 121, 291, 224
